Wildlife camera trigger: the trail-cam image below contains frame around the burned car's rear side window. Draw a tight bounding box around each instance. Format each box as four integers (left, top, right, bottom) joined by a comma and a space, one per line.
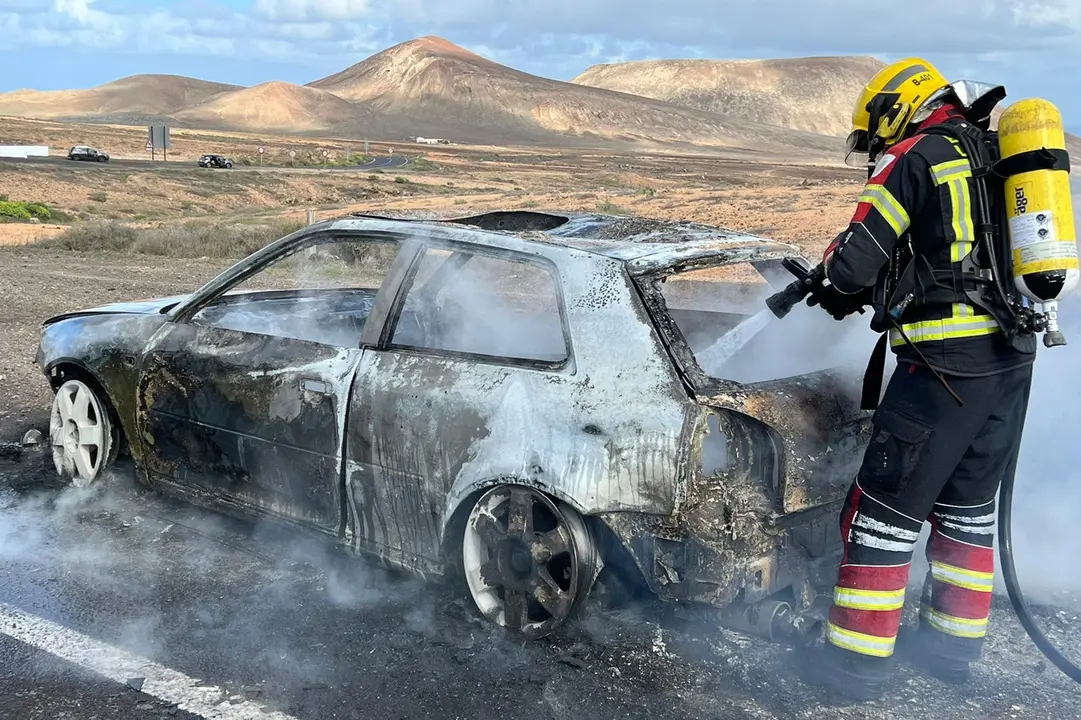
377, 238, 575, 372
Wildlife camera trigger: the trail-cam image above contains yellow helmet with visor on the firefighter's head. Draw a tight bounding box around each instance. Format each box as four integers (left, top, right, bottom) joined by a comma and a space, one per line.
845, 57, 950, 160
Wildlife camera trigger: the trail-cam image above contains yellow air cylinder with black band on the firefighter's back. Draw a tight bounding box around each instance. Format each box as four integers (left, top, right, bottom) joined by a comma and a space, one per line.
998, 98, 1079, 347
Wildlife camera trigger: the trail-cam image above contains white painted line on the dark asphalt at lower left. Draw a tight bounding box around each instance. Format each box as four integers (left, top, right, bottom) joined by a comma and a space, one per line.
0, 602, 296, 720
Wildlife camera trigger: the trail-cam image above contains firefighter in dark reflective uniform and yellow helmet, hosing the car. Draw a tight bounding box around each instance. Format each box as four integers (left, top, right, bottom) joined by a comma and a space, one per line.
803, 58, 1036, 699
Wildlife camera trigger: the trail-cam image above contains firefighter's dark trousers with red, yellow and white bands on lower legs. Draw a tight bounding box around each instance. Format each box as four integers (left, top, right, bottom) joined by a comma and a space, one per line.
826, 363, 1032, 675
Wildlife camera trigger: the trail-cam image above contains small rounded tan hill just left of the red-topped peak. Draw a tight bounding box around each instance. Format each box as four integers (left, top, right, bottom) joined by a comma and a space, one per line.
173, 82, 372, 134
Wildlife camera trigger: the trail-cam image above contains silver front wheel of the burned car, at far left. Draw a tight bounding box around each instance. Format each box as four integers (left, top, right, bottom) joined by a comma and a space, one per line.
49, 379, 115, 488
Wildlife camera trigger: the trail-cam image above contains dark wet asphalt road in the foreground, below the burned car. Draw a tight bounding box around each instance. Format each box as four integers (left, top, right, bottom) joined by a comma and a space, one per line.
0, 436, 1081, 720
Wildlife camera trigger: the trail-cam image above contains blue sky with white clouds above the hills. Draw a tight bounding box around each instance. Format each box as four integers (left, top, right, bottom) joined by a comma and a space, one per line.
0, 0, 1081, 128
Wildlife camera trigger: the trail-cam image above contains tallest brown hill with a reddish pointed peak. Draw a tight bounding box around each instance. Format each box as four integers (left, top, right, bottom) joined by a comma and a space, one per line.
309, 37, 838, 158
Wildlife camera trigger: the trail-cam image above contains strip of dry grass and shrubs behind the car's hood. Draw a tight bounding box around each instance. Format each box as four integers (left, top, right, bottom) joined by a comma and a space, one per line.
38, 218, 303, 258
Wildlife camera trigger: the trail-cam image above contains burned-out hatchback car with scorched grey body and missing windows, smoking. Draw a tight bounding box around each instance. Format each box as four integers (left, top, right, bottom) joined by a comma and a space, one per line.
37, 211, 869, 637
